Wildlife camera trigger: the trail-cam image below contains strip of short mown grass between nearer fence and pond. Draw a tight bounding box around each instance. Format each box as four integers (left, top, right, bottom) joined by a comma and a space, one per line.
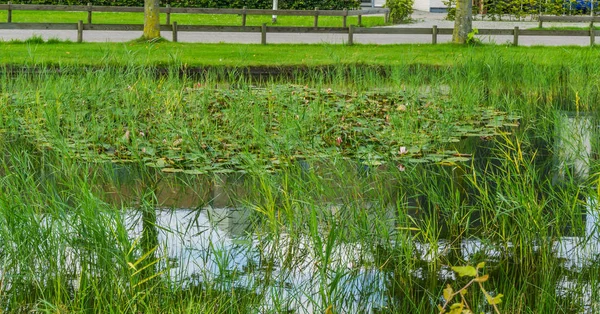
0, 39, 600, 67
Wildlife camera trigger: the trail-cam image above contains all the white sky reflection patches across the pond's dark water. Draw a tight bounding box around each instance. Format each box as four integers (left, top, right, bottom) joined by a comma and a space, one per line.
119, 201, 600, 313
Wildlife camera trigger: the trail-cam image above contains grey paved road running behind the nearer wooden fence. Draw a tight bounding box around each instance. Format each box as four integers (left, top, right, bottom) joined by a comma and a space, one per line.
0, 11, 590, 46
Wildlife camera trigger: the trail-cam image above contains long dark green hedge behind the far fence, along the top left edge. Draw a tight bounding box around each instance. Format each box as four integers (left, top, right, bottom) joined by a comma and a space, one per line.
0, 0, 360, 10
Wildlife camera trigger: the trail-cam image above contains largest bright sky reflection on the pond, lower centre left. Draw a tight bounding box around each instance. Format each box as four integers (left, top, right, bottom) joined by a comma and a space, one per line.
125, 208, 392, 313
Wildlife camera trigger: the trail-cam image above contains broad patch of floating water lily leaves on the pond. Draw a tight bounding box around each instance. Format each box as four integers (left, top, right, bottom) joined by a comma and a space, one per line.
0, 72, 517, 173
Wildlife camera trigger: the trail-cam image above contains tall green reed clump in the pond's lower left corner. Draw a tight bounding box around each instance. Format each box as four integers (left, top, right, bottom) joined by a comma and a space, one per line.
0, 139, 268, 313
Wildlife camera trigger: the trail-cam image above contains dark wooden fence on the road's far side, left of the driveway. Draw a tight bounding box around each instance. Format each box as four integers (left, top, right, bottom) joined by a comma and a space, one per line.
0, 2, 390, 27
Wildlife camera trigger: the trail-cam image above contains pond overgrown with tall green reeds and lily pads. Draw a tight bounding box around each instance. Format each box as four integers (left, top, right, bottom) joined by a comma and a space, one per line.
0, 57, 600, 313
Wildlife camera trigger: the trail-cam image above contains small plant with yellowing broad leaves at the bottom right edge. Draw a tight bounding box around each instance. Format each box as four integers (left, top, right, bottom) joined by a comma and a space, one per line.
438, 262, 503, 314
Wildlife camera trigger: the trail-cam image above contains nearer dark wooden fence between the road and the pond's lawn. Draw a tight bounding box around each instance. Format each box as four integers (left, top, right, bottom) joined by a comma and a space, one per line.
0, 21, 600, 46
